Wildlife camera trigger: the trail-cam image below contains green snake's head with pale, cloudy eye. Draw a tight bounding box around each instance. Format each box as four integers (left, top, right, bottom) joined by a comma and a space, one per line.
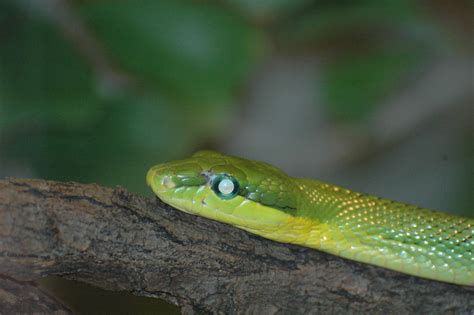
147, 151, 297, 230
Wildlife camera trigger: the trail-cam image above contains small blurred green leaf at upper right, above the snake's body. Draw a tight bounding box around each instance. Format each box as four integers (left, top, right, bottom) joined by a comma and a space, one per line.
322, 50, 421, 121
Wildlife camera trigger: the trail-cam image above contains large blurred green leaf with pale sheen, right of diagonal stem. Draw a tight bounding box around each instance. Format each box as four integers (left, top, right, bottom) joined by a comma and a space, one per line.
82, 0, 261, 105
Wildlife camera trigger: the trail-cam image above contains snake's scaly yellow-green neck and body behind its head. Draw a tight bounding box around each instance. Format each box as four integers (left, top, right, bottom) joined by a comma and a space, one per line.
289, 179, 474, 285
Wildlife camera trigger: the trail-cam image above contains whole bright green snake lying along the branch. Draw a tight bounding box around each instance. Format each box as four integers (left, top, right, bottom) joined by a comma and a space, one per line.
147, 151, 474, 286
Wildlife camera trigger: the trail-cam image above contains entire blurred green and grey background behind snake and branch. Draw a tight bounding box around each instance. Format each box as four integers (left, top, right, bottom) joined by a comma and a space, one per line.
0, 0, 474, 314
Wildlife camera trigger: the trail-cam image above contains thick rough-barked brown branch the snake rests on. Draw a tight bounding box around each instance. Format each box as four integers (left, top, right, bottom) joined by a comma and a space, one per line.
0, 179, 474, 314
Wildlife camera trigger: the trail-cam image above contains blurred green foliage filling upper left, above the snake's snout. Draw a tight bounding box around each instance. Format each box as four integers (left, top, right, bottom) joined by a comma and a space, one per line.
0, 0, 261, 191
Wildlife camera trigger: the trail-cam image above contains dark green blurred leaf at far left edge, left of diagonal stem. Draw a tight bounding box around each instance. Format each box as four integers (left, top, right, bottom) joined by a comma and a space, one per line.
0, 6, 100, 128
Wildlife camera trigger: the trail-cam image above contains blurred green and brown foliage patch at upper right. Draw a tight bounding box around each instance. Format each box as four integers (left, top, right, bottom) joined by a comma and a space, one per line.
279, 0, 440, 122
